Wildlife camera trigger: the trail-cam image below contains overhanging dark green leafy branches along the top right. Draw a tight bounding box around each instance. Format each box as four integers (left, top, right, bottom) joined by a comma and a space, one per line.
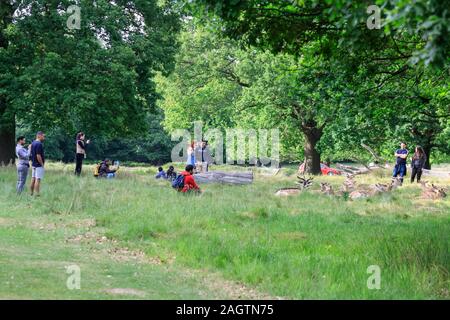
190, 0, 450, 67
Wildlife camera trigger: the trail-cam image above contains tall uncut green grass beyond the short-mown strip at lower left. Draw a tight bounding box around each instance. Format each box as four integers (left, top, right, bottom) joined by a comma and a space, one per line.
0, 165, 450, 299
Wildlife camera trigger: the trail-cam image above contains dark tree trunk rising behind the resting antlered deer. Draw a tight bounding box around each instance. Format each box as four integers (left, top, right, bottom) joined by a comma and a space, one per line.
302, 121, 323, 175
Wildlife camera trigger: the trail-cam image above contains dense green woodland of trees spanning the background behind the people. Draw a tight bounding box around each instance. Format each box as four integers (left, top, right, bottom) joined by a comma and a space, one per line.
0, 0, 450, 173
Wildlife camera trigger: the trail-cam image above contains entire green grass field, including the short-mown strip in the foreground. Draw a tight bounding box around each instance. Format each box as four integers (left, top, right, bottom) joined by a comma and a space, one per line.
0, 163, 450, 299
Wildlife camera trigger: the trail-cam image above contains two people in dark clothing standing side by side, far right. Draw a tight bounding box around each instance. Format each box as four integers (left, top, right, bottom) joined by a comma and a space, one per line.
392, 142, 427, 184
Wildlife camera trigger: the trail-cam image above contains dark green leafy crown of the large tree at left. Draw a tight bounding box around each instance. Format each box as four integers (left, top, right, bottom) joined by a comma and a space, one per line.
0, 0, 178, 137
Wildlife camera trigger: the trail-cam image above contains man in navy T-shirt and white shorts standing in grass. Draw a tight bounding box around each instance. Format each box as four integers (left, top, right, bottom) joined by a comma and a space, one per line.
30, 131, 45, 196
